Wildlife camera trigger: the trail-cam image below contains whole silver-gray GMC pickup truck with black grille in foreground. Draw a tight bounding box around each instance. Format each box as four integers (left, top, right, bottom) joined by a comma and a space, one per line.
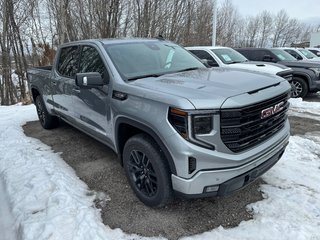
28, 39, 290, 207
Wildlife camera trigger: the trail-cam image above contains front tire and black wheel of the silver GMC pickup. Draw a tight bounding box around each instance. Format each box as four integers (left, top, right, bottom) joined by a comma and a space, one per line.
123, 134, 173, 207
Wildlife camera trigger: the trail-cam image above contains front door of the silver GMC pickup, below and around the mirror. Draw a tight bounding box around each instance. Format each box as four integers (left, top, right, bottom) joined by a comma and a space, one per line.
74, 45, 112, 141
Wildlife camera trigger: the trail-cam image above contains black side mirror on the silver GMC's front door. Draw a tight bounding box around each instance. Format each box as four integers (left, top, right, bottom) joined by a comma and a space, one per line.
76, 72, 106, 88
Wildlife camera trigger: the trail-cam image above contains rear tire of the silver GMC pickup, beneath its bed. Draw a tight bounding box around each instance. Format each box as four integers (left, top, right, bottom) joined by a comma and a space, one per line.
36, 95, 59, 129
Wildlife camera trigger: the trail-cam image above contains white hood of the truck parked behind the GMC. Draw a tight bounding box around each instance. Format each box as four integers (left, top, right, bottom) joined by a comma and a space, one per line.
230, 61, 290, 75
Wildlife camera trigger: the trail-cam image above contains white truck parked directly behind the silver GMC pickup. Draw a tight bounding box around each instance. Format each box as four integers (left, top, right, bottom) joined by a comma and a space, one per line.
186, 46, 293, 82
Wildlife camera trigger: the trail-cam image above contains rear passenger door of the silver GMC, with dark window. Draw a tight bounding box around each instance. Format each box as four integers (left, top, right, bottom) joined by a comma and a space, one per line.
51, 46, 79, 121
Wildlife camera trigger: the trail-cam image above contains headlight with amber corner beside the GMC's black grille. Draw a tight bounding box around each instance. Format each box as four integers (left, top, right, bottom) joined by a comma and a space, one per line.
168, 108, 215, 148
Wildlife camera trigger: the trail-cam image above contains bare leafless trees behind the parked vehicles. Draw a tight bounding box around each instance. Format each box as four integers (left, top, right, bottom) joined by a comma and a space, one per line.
0, 0, 320, 105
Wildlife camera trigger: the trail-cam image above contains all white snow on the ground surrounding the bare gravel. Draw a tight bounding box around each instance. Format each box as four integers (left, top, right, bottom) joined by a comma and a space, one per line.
0, 100, 320, 240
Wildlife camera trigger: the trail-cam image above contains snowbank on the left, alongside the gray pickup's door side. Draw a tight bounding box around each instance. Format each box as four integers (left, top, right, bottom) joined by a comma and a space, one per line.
0, 105, 159, 240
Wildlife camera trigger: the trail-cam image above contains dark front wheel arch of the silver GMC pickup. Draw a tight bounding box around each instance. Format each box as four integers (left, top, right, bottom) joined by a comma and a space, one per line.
115, 117, 177, 174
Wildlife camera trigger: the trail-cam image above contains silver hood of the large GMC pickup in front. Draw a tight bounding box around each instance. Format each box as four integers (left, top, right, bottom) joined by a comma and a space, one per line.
130, 68, 285, 109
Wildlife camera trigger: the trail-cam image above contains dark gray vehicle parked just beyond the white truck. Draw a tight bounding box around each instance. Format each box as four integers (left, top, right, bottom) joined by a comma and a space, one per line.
235, 48, 320, 98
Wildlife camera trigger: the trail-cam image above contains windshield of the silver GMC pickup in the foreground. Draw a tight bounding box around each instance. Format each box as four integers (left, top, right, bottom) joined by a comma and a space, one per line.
105, 40, 206, 80
